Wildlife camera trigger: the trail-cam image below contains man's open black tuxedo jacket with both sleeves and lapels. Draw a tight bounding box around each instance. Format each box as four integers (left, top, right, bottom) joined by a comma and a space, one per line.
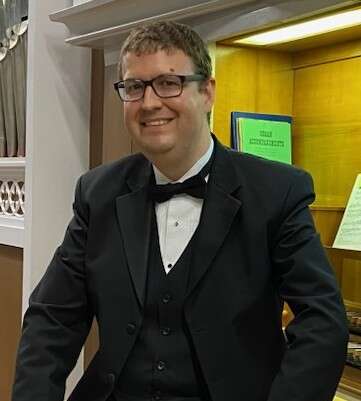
13, 137, 348, 401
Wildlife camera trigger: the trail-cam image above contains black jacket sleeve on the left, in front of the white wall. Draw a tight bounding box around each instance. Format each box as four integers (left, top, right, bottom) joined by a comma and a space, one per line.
12, 179, 92, 401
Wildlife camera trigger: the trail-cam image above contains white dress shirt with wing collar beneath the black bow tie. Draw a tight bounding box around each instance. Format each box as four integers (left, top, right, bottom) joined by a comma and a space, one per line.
153, 137, 214, 274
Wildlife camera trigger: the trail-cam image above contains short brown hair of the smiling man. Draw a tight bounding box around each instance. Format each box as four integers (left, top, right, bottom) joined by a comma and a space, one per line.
119, 21, 212, 78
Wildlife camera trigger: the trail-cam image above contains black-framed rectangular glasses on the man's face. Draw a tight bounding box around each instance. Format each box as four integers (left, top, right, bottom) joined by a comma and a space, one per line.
114, 74, 206, 102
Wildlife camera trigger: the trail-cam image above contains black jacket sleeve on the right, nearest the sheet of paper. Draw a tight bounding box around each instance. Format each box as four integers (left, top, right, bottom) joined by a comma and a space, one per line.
268, 171, 348, 401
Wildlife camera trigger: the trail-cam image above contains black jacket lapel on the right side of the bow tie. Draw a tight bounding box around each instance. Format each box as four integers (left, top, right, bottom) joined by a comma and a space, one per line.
188, 137, 242, 295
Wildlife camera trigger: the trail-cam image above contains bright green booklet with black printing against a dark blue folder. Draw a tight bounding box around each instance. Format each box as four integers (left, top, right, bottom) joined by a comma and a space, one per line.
237, 117, 292, 164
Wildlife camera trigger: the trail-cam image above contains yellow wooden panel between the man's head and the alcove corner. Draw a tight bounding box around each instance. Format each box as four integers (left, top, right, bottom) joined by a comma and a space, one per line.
213, 45, 293, 145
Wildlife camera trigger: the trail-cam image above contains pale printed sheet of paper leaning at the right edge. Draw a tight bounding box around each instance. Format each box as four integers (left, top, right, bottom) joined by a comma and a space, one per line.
333, 174, 361, 251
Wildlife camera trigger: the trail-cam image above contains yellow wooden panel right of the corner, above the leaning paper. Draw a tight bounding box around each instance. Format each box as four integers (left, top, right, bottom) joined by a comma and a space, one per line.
293, 57, 361, 207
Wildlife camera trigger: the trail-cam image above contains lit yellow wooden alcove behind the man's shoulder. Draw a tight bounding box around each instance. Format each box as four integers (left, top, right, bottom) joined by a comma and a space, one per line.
213, 15, 361, 397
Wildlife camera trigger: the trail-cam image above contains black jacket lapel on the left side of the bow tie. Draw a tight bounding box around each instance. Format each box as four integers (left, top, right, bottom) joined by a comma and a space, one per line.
116, 158, 153, 307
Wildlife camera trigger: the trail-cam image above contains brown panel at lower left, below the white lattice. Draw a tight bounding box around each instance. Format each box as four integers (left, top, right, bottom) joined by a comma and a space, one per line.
0, 245, 23, 401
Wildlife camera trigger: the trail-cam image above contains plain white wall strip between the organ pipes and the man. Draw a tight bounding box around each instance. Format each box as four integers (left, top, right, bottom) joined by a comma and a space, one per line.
23, 0, 91, 396
